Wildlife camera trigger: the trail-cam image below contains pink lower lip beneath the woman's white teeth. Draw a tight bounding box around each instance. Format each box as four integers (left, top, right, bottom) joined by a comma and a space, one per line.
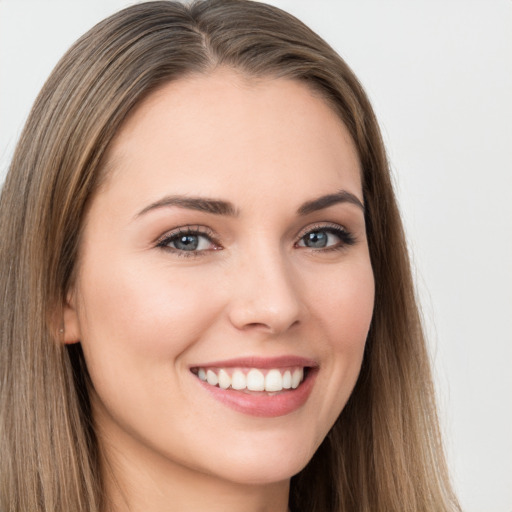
196, 369, 317, 418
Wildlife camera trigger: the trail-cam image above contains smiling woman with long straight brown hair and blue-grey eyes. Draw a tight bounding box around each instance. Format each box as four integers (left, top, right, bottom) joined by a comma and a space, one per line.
0, 0, 458, 512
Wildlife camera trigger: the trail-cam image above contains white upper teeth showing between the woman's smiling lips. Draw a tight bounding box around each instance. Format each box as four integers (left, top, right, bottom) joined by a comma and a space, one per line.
191, 366, 310, 393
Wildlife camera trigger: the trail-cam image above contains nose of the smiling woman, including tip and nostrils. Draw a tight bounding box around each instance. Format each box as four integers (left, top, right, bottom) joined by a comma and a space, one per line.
228, 249, 304, 335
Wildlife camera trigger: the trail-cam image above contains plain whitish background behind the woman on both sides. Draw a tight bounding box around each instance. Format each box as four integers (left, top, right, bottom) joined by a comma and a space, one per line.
0, 0, 512, 512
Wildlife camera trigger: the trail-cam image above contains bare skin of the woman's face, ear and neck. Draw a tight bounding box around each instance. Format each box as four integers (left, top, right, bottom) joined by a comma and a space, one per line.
64, 69, 374, 512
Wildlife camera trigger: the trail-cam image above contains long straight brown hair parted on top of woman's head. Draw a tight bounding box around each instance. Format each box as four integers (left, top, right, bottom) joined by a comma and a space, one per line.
0, 0, 459, 512
